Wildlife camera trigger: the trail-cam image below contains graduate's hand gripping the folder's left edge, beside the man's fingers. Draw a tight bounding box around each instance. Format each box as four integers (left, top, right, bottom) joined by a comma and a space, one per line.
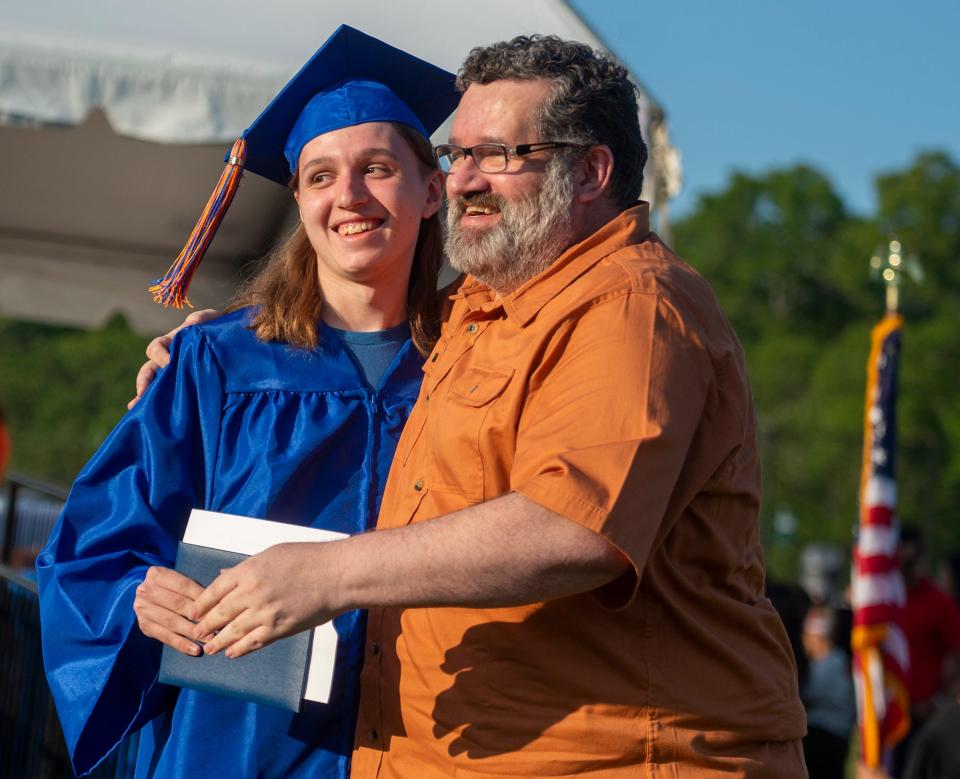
133, 565, 203, 657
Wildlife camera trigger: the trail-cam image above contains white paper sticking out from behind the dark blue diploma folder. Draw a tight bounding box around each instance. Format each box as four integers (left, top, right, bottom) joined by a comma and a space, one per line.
183, 509, 347, 703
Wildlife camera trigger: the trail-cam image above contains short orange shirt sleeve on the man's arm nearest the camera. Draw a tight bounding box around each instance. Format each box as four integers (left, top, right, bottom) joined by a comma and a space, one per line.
511, 292, 714, 607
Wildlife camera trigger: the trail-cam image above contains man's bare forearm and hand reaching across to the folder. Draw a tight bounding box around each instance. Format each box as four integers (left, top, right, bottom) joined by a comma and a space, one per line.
193, 493, 631, 657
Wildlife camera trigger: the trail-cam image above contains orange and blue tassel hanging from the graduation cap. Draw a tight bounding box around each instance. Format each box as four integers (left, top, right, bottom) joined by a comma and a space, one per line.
150, 138, 247, 308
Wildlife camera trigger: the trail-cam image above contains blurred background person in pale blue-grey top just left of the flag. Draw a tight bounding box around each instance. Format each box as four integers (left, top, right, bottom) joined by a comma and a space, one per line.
801, 605, 857, 779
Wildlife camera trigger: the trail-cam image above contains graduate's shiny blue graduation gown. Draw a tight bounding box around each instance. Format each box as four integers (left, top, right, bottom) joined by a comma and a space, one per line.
37, 311, 422, 777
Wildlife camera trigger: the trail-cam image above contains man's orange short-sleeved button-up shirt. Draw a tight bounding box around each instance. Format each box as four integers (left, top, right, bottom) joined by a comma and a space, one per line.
353, 204, 806, 779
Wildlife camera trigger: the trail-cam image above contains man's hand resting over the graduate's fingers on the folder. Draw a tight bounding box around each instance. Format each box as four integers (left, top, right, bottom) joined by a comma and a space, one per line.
193, 542, 344, 657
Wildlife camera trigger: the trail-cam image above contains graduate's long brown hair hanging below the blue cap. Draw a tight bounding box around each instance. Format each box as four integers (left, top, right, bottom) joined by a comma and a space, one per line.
227, 123, 443, 356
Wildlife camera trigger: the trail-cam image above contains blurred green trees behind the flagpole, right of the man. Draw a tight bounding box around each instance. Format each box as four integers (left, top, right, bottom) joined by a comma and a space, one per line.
674, 152, 960, 577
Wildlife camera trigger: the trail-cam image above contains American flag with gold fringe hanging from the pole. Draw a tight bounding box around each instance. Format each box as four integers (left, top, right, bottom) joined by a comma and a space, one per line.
852, 314, 910, 768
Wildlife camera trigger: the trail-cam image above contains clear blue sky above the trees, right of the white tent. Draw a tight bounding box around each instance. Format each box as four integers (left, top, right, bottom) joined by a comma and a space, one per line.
572, 0, 960, 214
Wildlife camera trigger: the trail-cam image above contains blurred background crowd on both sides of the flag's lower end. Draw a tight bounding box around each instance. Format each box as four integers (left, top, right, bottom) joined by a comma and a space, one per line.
768, 527, 960, 779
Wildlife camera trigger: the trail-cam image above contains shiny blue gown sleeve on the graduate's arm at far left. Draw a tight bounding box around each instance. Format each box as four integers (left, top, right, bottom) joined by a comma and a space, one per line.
37, 327, 223, 774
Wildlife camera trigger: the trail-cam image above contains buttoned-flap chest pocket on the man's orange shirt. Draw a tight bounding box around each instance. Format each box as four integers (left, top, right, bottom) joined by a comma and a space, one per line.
427, 366, 514, 501
